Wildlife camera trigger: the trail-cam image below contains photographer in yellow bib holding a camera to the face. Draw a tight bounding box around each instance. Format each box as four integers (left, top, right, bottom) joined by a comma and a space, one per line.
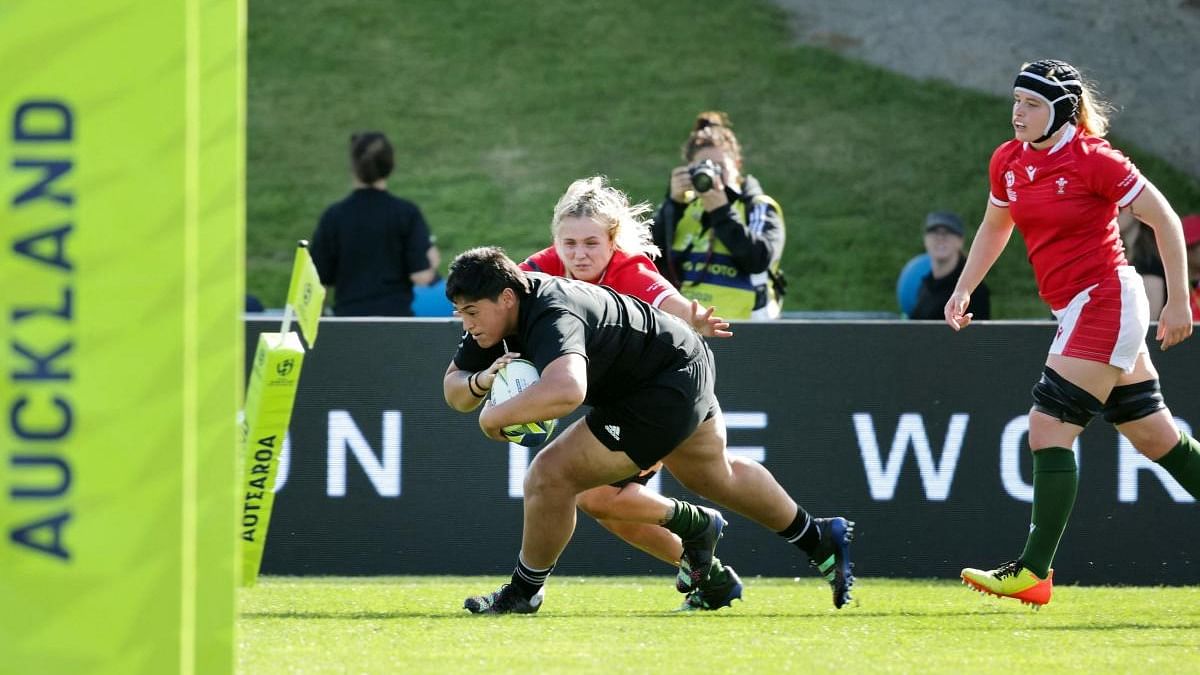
654, 112, 786, 319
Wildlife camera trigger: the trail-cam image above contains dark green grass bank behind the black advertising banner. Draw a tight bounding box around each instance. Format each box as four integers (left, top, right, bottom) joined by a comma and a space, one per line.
246, 0, 1200, 318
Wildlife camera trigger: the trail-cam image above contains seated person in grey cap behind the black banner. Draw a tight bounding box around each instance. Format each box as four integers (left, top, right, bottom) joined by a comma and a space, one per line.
908, 211, 991, 321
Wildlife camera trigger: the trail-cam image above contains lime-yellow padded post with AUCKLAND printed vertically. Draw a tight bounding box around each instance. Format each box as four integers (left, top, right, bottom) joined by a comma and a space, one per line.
0, 0, 246, 673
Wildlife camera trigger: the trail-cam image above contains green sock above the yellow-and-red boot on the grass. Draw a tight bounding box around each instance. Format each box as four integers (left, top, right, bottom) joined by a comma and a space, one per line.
1021, 448, 1079, 579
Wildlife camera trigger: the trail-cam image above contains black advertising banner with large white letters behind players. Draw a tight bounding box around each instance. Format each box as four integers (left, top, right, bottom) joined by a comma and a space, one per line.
246, 319, 1200, 584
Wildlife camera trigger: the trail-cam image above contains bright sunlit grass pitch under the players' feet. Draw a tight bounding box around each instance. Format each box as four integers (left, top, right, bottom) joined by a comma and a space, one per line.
238, 577, 1200, 674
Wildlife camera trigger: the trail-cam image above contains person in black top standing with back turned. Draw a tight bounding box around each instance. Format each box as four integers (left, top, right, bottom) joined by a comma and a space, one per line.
310, 131, 437, 316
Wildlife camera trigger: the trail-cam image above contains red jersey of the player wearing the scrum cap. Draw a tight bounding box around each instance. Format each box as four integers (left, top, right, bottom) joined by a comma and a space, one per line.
988, 125, 1146, 310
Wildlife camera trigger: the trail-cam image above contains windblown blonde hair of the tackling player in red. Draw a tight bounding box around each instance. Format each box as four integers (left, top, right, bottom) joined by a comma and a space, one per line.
550, 175, 660, 258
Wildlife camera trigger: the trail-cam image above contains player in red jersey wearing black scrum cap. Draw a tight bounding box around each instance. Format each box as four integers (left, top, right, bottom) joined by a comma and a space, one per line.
944, 60, 1200, 605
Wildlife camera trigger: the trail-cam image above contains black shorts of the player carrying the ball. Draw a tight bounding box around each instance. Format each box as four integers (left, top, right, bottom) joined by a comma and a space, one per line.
587, 345, 719, 470
